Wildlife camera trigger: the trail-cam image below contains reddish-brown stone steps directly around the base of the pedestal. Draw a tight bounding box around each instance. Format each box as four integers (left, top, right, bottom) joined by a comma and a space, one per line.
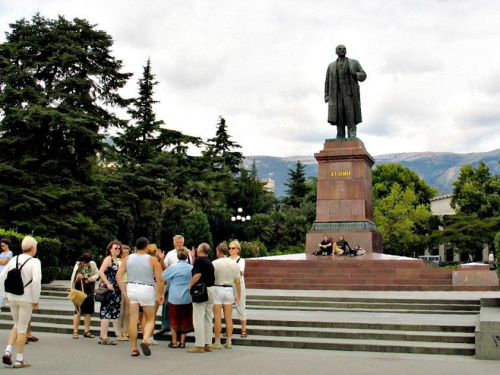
245, 254, 498, 291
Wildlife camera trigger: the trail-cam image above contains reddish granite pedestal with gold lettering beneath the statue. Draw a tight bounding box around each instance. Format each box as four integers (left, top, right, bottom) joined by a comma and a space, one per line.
306, 138, 382, 254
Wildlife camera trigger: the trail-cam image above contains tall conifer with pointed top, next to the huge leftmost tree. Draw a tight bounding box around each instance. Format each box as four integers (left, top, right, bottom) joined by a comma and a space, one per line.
110, 59, 201, 242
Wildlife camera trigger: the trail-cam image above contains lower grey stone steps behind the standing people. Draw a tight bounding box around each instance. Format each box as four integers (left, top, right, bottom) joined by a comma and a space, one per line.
0, 284, 480, 356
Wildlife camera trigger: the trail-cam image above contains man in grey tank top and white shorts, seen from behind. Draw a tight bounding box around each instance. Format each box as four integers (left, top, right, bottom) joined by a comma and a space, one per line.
116, 237, 164, 357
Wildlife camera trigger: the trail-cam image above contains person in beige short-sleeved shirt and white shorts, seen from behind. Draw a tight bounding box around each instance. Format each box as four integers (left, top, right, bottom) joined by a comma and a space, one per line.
212, 242, 241, 349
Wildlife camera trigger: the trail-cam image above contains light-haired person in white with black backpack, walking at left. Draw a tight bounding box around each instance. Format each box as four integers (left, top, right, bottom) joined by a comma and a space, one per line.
0, 236, 42, 368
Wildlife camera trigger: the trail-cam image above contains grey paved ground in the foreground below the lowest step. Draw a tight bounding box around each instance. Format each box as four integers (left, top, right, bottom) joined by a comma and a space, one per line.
0, 330, 500, 375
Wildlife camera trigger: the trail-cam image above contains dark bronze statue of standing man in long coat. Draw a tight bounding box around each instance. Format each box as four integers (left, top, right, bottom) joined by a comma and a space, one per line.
325, 45, 366, 138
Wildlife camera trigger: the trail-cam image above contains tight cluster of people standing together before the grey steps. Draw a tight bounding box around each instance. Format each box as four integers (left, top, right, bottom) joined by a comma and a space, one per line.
71, 235, 247, 357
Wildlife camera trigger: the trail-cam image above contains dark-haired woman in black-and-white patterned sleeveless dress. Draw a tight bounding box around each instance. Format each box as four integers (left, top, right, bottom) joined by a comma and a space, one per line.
99, 240, 122, 345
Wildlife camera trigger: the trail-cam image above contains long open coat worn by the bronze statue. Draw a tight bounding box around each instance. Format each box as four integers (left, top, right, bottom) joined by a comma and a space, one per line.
325, 58, 366, 125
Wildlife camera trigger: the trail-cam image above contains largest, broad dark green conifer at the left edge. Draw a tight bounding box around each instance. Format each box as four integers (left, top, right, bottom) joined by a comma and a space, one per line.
0, 14, 130, 262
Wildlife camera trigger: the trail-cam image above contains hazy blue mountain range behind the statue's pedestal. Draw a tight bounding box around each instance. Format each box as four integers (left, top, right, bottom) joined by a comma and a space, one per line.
245, 149, 500, 197
